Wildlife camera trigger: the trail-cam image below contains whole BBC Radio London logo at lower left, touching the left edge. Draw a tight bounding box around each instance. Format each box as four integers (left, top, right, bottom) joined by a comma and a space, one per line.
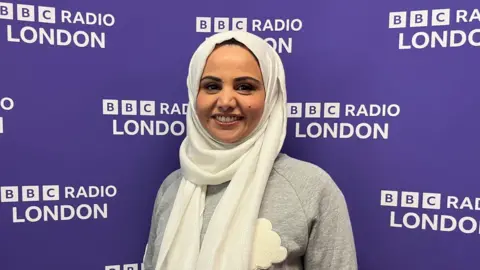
0, 185, 118, 223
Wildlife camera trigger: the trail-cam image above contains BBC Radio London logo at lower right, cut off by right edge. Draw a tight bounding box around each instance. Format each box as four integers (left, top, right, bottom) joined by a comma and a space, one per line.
380, 190, 480, 234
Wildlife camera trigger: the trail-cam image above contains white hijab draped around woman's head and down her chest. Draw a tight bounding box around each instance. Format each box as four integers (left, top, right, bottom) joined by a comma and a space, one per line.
155, 31, 287, 270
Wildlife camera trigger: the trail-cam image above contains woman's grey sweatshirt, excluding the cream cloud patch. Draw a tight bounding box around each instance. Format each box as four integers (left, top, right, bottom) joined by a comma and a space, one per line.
144, 154, 357, 270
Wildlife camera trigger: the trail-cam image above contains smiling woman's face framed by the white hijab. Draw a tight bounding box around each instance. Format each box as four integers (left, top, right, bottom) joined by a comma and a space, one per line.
196, 45, 265, 143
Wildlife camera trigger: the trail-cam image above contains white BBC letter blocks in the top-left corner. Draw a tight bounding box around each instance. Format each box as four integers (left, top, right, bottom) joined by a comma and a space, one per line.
0, 2, 55, 24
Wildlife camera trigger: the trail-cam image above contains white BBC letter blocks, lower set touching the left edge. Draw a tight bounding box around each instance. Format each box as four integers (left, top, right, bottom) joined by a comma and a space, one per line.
0, 185, 60, 202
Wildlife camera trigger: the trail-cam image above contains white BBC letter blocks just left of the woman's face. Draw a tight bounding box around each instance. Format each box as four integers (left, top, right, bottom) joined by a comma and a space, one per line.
103, 99, 155, 116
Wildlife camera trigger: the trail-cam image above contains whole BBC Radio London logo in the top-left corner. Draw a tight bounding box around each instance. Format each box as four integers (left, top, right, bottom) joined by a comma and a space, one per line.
0, 2, 115, 49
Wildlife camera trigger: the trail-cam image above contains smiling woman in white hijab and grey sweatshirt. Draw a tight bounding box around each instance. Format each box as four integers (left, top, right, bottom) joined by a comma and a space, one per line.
144, 31, 357, 270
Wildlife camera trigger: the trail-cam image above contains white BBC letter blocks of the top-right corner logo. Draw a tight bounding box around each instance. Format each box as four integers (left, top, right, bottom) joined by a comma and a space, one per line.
388, 8, 450, 28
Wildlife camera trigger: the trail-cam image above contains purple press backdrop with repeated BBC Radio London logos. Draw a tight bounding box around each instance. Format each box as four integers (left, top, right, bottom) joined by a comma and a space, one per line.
0, 0, 480, 270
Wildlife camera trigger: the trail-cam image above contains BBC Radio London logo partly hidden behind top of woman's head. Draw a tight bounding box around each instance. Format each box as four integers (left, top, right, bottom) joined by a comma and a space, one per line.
196, 17, 303, 54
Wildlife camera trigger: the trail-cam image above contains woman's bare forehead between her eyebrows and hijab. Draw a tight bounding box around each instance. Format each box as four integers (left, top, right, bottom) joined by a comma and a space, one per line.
204, 45, 261, 79
